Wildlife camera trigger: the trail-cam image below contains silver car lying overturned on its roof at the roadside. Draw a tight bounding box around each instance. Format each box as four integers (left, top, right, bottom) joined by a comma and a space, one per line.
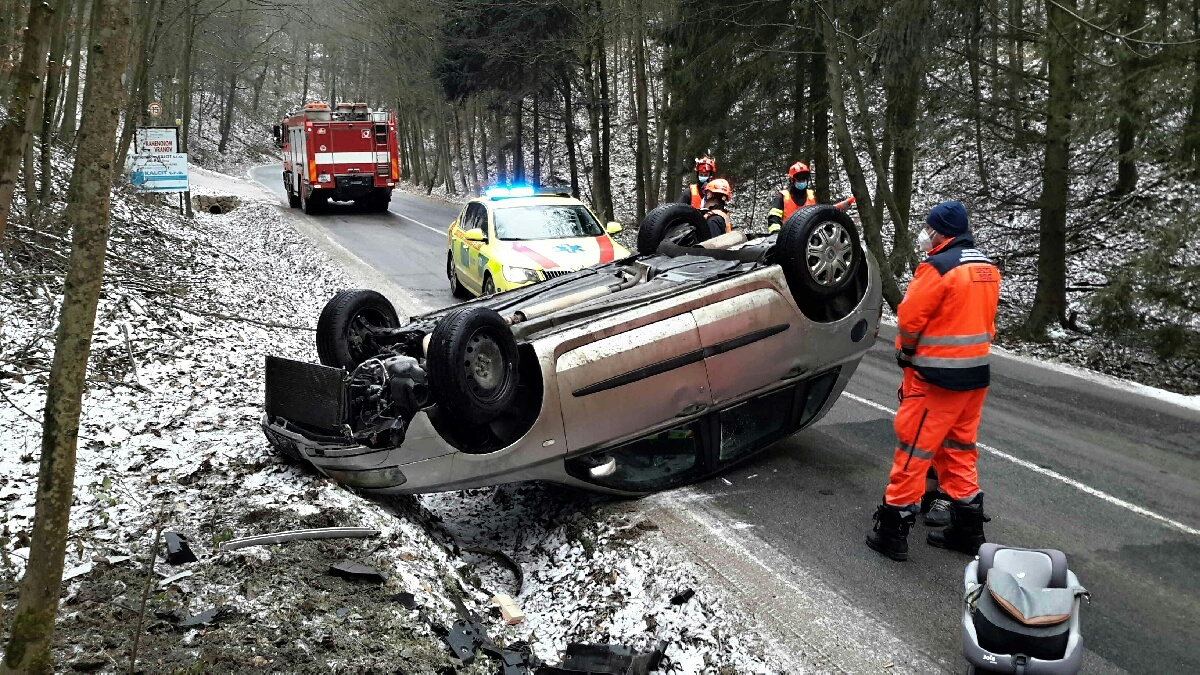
262, 204, 882, 495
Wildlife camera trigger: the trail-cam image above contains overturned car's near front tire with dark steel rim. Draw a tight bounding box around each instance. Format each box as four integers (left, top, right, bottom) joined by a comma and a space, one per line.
425, 306, 518, 425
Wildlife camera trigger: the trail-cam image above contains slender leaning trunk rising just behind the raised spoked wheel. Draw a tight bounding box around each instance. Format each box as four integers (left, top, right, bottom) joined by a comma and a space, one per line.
817, 6, 904, 311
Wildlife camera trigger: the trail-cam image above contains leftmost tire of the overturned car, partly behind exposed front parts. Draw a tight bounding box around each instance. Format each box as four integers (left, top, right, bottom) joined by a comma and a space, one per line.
317, 288, 400, 370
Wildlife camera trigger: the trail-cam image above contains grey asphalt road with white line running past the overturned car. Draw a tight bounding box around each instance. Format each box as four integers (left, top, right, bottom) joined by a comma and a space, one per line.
254, 167, 1200, 673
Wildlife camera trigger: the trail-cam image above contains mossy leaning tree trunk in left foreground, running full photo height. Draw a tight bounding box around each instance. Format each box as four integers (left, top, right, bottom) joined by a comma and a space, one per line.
2, 0, 131, 673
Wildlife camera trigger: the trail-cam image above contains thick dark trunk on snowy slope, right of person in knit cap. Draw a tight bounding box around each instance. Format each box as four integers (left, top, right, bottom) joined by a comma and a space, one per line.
1025, 0, 1078, 336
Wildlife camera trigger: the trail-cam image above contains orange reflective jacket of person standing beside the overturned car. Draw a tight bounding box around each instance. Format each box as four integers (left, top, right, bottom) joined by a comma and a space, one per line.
896, 235, 1000, 392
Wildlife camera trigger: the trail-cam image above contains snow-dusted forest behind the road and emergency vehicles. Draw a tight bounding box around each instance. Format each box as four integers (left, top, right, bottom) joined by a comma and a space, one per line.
0, 0, 1200, 384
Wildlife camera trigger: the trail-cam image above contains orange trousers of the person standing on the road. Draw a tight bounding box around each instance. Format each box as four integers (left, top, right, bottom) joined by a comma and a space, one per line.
883, 368, 988, 506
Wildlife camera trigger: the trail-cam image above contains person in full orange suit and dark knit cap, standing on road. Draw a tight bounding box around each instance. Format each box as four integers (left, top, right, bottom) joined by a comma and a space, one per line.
866, 202, 1000, 560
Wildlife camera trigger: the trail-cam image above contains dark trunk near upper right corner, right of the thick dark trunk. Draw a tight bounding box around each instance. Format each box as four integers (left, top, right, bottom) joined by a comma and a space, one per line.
1114, 0, 1146, 196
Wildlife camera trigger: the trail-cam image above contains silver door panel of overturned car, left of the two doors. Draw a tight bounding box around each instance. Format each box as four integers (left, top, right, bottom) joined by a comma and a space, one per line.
556, 312, 713, 452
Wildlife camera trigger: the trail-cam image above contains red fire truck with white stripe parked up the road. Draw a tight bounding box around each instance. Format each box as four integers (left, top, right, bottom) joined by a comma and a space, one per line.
275, 102, 400, 214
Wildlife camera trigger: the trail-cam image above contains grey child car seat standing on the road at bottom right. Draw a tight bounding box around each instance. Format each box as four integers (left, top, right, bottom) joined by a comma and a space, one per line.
962, 544, 1087, 675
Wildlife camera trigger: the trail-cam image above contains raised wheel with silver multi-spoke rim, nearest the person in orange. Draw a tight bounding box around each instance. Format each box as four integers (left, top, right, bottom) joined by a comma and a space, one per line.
775, 205, 864, 299
